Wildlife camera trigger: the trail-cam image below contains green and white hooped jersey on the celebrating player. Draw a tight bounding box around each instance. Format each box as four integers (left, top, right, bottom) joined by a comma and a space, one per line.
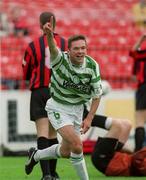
51, 51, 102, 105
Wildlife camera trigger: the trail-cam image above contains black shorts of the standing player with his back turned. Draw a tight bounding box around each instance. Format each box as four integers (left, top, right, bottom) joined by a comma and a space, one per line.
30, 88, 50, 121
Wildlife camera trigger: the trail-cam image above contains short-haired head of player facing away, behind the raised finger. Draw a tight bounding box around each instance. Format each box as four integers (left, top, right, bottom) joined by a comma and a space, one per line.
40, 12, 56, 29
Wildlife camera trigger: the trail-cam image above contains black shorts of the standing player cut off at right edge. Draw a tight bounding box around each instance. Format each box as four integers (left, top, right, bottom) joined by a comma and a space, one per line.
135, 84, 146, 110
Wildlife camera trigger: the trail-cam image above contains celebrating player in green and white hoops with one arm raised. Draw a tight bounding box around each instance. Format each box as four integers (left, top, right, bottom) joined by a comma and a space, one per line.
25, 17, 102, 180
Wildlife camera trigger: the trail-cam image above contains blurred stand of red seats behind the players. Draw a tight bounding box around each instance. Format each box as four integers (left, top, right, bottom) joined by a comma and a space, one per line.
0, 0, 142, 89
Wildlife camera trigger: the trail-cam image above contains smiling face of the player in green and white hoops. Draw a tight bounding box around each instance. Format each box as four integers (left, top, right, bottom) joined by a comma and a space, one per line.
69, 40, 87, 65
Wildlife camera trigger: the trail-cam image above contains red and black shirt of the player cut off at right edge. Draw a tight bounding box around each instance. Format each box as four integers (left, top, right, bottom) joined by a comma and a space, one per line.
130, 50, 146, 85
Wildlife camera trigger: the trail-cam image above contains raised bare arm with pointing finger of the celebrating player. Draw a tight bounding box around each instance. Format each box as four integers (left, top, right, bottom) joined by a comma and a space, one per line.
43, 16, 59, 60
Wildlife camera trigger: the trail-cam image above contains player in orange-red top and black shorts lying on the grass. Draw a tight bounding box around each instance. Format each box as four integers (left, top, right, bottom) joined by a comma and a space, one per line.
91, 116, 146, 176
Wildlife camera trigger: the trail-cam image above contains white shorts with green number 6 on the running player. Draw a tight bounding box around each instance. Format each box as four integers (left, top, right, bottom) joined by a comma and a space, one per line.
45, 98, 84, 133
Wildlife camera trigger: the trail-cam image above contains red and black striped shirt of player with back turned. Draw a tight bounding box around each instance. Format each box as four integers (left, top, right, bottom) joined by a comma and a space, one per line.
22, 33, 67, 90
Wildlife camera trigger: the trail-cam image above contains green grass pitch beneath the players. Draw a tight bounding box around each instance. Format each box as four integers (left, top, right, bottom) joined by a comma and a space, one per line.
0, 156, 146, 180
